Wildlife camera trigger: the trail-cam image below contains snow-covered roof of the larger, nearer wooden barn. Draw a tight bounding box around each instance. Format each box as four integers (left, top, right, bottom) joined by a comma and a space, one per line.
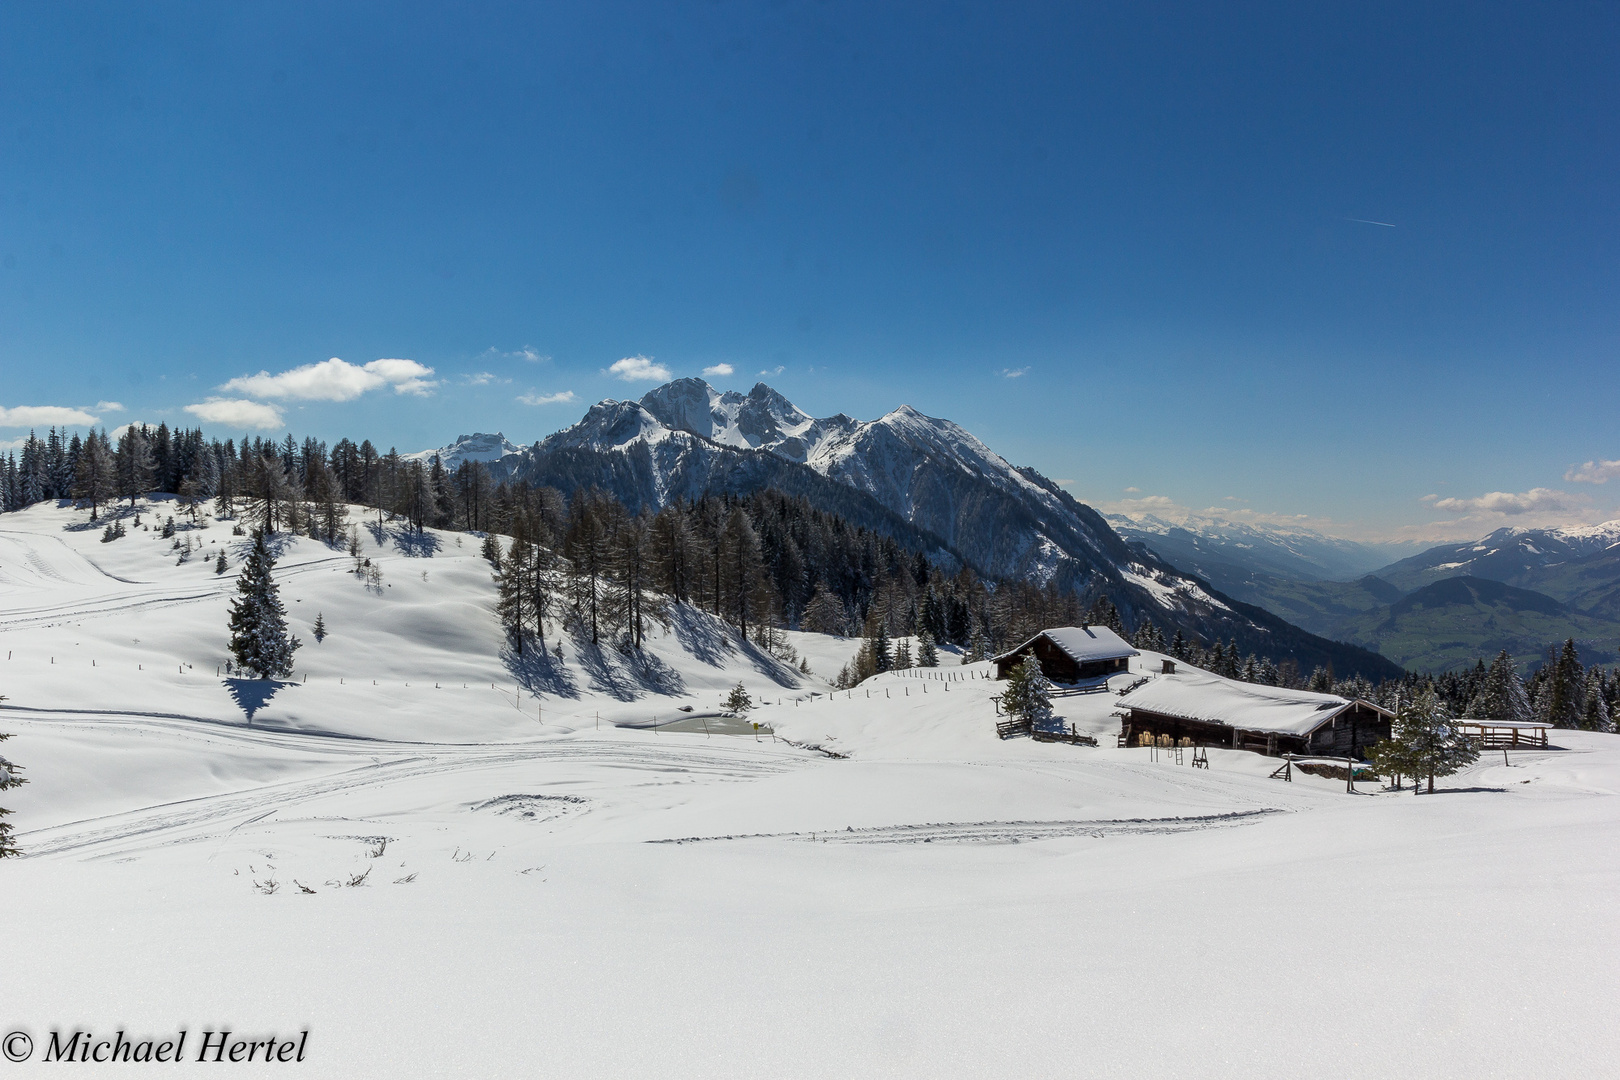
1118, 669, 1385, 735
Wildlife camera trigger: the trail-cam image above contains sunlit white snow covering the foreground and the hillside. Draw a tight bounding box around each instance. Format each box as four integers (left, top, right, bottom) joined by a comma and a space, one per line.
0, 507, 1620, 1077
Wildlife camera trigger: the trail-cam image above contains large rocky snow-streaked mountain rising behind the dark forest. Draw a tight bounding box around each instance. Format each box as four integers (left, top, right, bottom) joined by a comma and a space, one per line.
421, 379, 1398, 678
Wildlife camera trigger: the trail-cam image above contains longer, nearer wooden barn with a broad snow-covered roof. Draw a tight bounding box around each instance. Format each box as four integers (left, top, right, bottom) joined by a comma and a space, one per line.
1116, 669, 1395, 759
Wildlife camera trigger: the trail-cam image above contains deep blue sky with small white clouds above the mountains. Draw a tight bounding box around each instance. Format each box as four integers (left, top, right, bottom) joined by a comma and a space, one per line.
0, 2, 1620, 536
